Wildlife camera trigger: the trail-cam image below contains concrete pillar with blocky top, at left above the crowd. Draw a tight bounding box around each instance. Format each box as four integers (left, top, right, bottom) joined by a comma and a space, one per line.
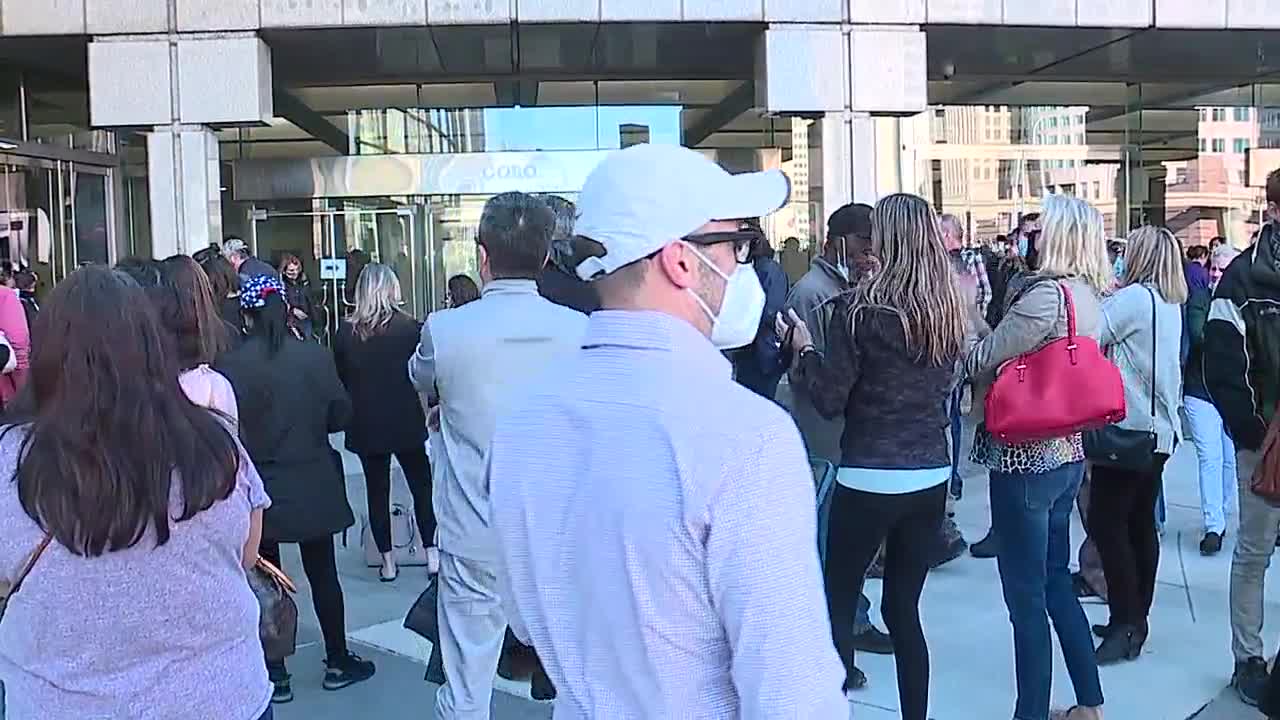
88, 31, 274, 258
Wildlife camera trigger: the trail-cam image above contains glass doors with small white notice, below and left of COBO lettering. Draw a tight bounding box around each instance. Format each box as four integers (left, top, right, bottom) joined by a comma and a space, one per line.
250, 200, 430, 337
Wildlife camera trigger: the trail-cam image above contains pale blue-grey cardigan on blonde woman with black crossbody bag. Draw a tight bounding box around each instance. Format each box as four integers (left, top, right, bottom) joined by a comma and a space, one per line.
1100, 284, 1183, 455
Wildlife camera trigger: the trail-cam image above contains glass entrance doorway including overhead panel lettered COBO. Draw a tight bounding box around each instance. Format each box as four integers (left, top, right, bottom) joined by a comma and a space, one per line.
223, 150, 605, 332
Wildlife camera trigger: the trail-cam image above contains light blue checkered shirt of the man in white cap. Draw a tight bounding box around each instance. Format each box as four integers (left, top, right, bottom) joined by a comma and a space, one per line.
489, 311, 849, 720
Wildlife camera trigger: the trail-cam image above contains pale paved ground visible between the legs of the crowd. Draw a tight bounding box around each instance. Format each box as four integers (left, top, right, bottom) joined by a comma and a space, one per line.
278, 415, 1280, 720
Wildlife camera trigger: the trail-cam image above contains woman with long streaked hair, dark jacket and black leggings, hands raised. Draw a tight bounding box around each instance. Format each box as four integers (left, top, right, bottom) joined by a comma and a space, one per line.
778, 195, 966, 720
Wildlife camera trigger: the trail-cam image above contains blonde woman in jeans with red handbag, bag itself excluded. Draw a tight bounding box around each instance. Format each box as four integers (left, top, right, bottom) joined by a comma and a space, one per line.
964, 195, 1111, 720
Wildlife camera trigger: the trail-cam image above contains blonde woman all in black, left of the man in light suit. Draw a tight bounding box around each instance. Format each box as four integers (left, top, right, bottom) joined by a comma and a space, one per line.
334, 263, 435, 583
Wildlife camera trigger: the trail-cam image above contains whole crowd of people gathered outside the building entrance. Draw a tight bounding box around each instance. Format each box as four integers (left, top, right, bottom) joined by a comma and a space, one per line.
0, 145, 1280, 720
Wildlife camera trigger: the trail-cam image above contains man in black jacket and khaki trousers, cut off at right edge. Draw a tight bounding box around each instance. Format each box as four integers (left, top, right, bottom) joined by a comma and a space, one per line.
1203, 170, 1280, 705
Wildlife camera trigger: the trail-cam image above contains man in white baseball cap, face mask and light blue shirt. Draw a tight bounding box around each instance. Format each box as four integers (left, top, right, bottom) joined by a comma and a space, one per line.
488, 145, 849, 720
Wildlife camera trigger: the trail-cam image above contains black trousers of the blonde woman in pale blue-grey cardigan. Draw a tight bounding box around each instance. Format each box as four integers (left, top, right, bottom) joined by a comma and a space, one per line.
1089, 455, 1169, 629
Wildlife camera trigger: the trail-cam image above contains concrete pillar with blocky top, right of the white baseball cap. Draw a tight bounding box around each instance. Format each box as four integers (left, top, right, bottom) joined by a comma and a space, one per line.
755, 24, 927, 228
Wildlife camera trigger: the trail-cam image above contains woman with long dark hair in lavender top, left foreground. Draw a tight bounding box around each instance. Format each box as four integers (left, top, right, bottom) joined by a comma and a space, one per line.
0, 265, 271, 720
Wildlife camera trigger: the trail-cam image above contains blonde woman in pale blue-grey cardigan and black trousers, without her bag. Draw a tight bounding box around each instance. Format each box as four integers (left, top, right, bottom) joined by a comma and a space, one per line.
1089, 225, 1187, 665
